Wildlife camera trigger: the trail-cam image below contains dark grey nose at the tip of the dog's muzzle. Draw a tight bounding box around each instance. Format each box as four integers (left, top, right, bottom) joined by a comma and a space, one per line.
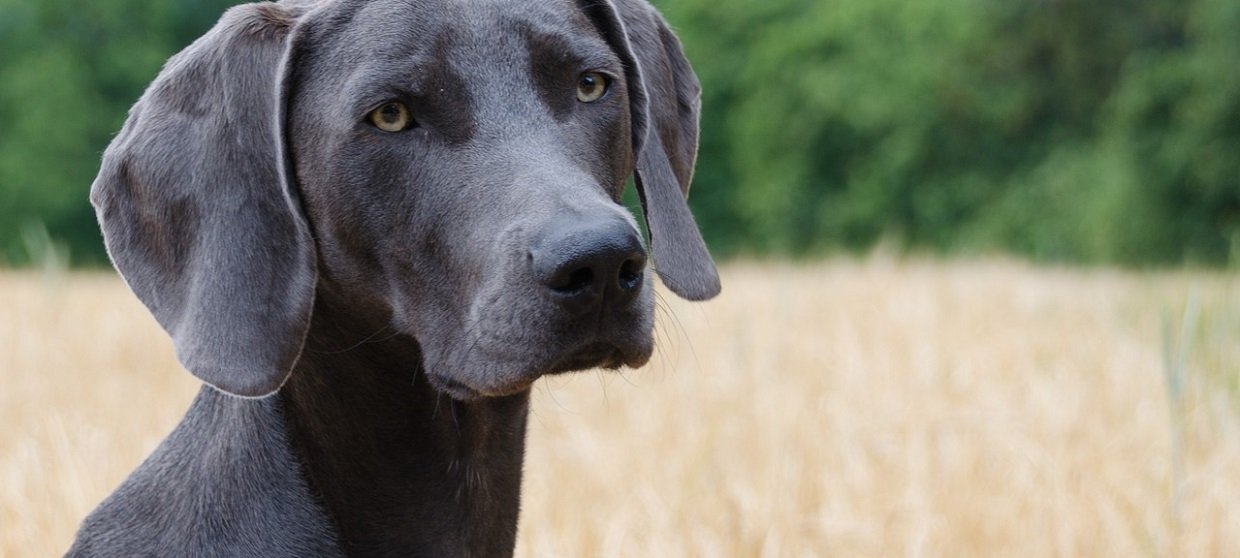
529, 218, 646, 311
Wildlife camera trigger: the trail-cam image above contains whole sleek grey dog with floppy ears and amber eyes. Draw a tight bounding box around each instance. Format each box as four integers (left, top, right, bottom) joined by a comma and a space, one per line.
69, 0, 719, 557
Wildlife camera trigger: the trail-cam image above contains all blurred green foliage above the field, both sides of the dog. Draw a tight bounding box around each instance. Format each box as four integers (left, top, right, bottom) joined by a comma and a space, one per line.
0, 0, 1240, 264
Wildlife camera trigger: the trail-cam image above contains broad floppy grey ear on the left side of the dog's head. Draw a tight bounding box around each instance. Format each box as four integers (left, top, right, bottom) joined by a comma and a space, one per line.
91, 4, 316, 397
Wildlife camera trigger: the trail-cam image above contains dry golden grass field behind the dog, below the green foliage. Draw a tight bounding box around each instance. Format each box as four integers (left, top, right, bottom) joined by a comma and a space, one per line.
0, 259, 1240, 557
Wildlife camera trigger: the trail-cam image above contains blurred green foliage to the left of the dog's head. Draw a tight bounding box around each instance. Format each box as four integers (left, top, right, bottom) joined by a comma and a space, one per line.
0, 0, 231, 264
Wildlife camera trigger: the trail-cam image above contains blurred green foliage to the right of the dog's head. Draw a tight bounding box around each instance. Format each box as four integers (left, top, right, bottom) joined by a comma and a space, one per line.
661, 0, 1240, 264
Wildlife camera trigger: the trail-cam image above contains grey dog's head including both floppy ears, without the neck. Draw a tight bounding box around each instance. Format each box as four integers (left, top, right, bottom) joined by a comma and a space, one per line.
92, 0, 719, 398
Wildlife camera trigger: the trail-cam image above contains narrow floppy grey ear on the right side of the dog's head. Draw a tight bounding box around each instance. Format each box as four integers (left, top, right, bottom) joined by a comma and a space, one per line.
578, 0, 720, 300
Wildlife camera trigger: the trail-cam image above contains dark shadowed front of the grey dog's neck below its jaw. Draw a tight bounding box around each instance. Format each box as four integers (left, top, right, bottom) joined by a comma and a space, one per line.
280, 293, 529, 557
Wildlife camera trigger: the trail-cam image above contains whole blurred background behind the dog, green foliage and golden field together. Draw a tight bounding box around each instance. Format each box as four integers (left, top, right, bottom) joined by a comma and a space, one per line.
0, 0, 1240, 558
